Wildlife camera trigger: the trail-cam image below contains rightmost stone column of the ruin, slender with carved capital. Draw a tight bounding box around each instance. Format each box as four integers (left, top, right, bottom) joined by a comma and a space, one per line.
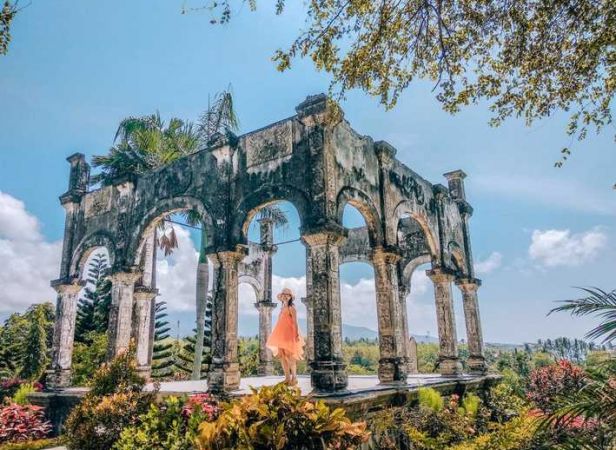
456, 279, 487, 374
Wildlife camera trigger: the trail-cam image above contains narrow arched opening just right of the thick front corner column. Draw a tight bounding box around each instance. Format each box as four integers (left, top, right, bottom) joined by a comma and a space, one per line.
340, 203, 380, 375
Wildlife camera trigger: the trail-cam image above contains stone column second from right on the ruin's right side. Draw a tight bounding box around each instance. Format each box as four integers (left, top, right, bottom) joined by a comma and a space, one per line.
426, 269, 462, 375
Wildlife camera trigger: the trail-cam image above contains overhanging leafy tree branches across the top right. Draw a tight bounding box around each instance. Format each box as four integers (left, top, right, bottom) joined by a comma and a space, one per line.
207, 0, 616, 171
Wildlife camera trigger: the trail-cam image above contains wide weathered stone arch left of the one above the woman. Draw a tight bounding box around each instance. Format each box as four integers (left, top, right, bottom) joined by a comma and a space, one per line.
126, 196, 218, 266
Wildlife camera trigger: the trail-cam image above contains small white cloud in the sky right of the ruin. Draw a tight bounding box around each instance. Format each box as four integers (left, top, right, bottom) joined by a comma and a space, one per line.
528, 228, 607, 267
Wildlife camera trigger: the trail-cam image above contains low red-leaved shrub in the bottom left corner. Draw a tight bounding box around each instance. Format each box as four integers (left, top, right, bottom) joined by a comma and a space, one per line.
0, 403, 51, 444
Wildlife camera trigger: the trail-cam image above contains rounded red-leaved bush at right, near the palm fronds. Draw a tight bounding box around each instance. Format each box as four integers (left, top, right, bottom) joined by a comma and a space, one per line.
526, 359, 585, 413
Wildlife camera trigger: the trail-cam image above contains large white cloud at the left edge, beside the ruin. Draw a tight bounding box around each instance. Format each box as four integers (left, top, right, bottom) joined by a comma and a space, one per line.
0, 192, 62, 312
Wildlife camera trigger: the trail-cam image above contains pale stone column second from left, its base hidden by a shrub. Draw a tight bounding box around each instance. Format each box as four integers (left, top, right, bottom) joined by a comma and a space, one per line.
107, 272, 142, 359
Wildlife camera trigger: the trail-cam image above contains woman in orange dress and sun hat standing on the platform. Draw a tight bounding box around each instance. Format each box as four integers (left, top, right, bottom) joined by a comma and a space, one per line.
265, 288, 304, 386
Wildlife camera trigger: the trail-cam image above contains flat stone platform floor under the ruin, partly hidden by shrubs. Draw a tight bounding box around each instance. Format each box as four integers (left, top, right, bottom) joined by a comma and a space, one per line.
29, 374, 499, 432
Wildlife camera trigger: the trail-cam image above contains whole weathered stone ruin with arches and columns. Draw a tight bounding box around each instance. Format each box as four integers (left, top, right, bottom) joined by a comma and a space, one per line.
48, 95, 485, 392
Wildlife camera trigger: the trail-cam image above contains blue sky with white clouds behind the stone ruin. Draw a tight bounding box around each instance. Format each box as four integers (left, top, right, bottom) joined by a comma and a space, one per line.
0, 0, 616, 342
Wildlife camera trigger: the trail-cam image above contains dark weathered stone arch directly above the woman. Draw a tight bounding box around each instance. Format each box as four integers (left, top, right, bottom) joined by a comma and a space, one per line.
232, 184, 311, 244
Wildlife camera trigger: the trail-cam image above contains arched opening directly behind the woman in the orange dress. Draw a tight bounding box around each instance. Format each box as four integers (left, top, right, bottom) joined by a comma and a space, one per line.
238, 200, 309, 376
